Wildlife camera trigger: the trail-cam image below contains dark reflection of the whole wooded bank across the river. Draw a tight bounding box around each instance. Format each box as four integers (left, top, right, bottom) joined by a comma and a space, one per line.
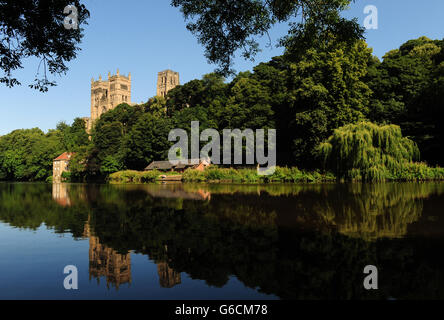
0, 183, 444, 299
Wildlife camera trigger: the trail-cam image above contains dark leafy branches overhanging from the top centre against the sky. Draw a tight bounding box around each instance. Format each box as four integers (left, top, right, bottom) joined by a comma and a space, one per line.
171, 0, 362, 75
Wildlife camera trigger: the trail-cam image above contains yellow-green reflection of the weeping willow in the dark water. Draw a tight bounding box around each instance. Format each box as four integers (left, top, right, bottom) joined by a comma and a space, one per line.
314, 183, 429, 240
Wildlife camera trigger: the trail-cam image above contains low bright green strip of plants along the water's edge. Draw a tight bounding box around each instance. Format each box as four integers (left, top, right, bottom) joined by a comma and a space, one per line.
107, 163, 444, 184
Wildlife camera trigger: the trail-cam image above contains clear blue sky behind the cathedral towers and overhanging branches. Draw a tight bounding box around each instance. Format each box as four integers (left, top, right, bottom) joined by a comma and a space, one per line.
0, 0, 444, 135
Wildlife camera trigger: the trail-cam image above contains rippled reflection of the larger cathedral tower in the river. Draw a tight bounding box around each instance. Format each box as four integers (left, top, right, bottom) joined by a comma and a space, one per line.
84, 222, 131, 289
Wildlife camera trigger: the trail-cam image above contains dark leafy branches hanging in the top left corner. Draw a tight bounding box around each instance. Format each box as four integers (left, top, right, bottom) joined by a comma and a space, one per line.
0, 0, 89, 91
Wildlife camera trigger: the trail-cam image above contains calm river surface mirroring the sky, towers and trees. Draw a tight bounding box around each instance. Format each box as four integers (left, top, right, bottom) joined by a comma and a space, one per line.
0, 183, 444, 299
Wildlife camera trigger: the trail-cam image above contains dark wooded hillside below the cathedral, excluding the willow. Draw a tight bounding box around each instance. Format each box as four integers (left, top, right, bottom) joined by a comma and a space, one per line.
0, 34, 444, 180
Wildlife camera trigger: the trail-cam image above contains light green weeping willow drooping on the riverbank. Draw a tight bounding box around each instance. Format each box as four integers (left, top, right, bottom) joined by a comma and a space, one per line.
318, 122, 419, 181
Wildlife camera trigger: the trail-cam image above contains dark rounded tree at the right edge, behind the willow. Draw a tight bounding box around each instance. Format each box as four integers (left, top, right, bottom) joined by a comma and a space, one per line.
366, 37, 444, 165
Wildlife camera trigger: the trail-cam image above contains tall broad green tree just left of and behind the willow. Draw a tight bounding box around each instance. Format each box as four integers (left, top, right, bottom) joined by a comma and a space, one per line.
286, 35, 371, 167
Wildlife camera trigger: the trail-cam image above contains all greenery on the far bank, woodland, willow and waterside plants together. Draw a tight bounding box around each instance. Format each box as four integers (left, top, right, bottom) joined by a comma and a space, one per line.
0, 35, 444, 183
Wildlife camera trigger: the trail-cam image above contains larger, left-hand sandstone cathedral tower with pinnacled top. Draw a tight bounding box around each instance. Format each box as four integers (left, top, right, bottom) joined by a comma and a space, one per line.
88, 69, 131, 123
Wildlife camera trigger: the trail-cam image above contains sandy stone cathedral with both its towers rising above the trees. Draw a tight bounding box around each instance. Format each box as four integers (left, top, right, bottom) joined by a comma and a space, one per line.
83, 69, 180, 132
